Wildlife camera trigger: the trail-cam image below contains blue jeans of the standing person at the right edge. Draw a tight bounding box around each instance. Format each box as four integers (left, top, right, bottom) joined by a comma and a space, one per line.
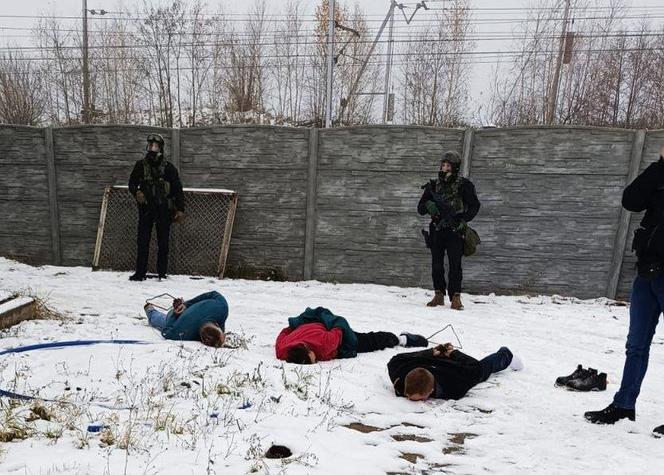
613, 276, 664, 409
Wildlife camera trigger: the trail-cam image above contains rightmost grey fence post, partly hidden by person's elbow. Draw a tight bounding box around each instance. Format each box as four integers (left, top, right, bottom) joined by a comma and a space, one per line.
606, 130, 646, 299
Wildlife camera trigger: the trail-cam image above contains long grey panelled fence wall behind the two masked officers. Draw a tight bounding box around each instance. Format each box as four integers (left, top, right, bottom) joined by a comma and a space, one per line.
0, 126, 664, 297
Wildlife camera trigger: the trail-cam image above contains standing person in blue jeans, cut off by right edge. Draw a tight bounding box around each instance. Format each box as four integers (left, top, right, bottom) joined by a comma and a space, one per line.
585, 146, 664, 437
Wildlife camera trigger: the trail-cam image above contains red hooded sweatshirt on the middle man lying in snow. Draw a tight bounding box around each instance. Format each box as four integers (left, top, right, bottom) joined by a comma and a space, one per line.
275, 323, 343, 361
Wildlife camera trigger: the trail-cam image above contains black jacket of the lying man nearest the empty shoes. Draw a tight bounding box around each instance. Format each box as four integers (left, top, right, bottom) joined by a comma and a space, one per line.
387, 349, 482, 399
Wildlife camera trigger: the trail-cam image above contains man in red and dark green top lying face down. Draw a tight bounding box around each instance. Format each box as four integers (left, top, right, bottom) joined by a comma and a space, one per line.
275, 307, 429, 364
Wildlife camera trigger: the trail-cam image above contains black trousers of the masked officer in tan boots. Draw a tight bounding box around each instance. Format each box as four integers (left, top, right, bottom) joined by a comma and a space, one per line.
430, 228, 463, 297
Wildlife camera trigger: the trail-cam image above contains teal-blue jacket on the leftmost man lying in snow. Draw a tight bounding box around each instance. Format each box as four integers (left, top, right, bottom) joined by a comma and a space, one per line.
161, 290, 228, 341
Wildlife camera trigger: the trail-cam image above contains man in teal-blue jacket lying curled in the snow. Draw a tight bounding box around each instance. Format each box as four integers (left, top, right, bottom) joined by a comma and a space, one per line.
144, 290, 228, 348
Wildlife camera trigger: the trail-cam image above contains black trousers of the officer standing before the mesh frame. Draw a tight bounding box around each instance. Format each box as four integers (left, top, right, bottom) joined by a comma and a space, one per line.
136, 206, 171, 276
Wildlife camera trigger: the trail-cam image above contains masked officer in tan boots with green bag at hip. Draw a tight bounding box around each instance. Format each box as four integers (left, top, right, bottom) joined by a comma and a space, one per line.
417, 152, 480, 310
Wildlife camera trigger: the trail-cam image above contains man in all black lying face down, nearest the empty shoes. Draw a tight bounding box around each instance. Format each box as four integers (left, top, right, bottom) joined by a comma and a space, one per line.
387, 343, 523, 401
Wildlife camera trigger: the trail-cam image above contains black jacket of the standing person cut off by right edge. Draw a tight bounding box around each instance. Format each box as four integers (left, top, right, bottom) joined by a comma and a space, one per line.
622, 159, 664, 264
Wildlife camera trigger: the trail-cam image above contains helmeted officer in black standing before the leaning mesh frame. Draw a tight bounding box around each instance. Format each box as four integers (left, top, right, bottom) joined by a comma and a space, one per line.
129, 134, 184, 280
